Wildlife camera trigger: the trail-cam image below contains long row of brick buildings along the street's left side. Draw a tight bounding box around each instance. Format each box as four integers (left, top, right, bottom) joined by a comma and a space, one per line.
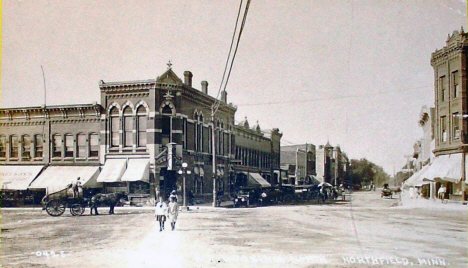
0, 64, 347, 205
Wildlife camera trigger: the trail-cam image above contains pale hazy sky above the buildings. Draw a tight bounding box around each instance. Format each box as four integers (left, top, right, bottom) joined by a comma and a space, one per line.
0, 0, 467, 175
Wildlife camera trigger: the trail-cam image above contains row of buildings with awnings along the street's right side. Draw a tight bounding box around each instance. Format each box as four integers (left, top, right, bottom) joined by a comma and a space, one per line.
403, 28, 468, 201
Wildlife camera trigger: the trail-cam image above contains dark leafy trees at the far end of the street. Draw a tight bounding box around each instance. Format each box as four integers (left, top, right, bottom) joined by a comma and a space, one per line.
349, 158, 390, 187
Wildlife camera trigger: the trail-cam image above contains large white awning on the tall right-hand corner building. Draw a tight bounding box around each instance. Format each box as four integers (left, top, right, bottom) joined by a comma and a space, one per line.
423, 154, 462, 183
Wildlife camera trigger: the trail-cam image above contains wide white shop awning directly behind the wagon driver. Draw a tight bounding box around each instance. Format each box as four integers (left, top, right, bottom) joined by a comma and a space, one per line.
28, 166, 99, 193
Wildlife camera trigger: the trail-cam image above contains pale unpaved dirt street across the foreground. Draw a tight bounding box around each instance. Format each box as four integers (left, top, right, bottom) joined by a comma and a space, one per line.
1, 191, 468, 268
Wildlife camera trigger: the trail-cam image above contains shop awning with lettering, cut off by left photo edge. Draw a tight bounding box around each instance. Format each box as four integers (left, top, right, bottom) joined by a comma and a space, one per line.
0, 166, 44, 190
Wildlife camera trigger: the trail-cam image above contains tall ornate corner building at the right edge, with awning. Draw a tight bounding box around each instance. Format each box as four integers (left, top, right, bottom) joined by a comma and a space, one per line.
429, 28, 468, 200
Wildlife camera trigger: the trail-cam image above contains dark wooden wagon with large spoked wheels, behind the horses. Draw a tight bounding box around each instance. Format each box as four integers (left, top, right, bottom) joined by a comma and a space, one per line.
42, 187, 88, 217
